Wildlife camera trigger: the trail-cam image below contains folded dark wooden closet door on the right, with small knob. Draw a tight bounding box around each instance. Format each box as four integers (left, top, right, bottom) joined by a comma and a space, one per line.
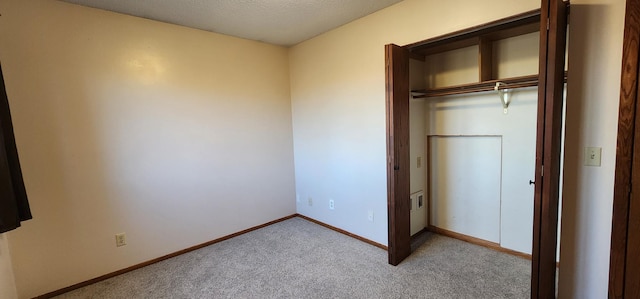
531, 0, 567, 298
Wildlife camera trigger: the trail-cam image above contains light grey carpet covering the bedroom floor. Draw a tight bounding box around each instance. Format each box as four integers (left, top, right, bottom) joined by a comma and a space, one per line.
57, 218, 531, 298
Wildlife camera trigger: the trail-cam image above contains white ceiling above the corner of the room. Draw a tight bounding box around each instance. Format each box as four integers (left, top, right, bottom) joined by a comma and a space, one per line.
61, 0, 401, 46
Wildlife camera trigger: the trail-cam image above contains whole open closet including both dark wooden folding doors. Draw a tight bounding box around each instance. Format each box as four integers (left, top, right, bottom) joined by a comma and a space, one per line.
385, 0, 568, 298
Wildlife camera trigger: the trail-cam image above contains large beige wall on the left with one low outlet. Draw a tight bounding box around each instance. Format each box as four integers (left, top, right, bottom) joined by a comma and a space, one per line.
0, 0, 295, 298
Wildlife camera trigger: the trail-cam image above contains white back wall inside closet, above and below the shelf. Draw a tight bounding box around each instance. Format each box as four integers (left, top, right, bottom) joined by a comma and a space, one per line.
420, 33, 539, 253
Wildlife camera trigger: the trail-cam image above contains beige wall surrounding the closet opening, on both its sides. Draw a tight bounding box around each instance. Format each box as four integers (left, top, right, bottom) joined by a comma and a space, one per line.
289, 0, 624, 298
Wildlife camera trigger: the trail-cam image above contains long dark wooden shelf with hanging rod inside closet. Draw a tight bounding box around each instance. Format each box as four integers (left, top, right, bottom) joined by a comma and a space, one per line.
411, 72, 567, 99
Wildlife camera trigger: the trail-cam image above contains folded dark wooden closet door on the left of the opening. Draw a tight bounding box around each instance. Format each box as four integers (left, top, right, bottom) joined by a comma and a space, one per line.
385, 44, 411, 266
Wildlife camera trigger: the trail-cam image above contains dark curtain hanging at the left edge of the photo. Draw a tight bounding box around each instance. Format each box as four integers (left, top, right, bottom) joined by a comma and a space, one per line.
0, 65, 31, 233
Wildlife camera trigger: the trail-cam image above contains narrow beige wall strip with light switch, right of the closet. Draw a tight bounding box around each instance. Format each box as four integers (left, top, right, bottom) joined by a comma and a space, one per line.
559, 0, 625, 298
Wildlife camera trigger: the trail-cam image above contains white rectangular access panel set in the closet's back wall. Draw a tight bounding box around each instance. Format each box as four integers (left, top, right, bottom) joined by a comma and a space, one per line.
428, 135, 502, 243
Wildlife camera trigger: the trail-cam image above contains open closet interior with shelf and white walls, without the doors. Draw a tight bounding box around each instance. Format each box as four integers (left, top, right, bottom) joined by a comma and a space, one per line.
409, 13, 539, 258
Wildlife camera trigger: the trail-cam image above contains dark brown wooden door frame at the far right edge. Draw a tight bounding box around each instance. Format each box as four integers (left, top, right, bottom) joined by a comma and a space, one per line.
609, 0, 640, 298
